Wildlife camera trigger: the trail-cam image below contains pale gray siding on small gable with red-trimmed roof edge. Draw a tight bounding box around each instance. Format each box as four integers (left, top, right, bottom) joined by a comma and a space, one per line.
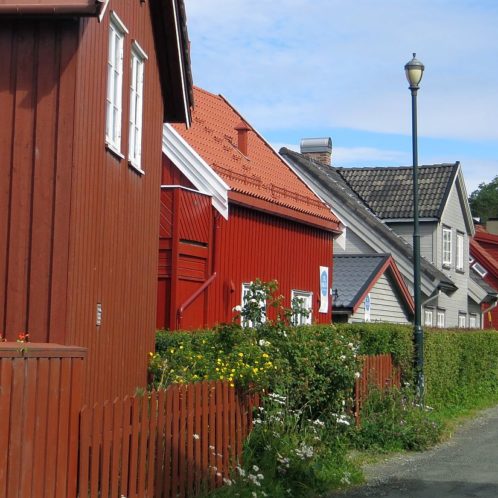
349, 274, 409, 323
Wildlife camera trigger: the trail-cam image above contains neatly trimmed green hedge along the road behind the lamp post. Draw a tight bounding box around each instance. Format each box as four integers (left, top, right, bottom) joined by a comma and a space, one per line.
338, 323, 498, 409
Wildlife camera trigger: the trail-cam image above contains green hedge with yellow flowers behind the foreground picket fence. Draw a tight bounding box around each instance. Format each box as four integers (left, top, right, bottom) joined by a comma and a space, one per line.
150, 324, 360, 424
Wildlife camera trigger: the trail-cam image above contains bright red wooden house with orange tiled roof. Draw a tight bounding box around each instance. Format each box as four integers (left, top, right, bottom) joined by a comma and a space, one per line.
157, 88, 340, 329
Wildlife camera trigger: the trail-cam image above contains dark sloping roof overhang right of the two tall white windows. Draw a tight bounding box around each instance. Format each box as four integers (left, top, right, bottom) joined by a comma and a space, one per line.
149, 0, 194, 127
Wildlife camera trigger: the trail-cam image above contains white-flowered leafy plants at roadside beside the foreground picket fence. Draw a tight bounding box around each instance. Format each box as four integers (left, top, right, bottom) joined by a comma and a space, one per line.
203, 394, 360, 498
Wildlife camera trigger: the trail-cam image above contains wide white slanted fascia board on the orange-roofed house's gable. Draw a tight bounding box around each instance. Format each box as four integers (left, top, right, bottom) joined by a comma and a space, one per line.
162, 124, 230, 220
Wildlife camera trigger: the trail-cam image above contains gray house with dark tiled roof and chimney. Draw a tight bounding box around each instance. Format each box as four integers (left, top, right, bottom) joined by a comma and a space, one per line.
280, 139, 489, 327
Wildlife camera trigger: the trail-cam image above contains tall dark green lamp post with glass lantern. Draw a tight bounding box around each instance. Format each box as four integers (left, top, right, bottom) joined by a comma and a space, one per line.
405, 53, 424, 402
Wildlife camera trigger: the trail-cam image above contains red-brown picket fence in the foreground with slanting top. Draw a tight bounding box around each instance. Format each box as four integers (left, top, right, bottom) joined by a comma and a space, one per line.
78, 382, 257, 498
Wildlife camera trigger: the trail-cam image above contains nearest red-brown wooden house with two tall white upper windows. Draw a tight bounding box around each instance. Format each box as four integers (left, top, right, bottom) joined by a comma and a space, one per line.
0, 0, 192, 401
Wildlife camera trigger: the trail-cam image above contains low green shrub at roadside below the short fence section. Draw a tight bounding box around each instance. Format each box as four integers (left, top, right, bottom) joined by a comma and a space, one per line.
355, 388, 442, 451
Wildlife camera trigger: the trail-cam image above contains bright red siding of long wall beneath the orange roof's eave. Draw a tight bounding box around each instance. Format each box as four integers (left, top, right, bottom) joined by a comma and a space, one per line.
208, 204, 332, 325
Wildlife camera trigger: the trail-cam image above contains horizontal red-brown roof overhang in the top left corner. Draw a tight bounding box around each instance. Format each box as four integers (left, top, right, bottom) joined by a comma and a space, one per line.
0, 0, 109, 17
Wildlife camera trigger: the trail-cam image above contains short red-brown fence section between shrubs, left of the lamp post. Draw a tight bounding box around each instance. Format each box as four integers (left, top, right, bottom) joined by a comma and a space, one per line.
354, 354, 401, 424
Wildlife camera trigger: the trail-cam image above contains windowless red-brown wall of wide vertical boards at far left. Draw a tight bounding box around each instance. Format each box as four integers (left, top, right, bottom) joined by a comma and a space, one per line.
0, 19, 77, 342
